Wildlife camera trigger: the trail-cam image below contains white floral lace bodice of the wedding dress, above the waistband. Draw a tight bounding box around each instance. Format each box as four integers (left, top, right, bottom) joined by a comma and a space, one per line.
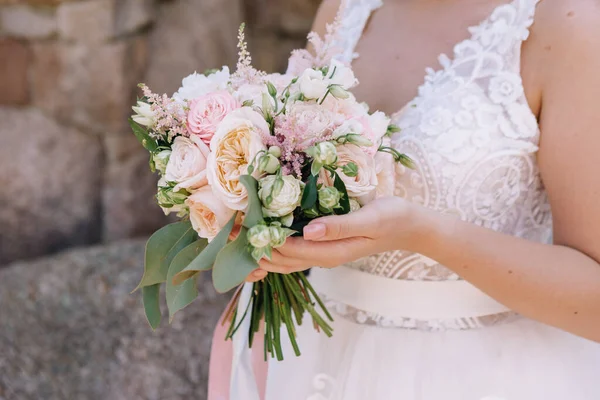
326, 0, 551, 323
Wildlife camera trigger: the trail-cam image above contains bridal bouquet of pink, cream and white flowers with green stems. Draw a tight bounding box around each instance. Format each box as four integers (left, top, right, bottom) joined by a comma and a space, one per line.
130, 26, 410, 360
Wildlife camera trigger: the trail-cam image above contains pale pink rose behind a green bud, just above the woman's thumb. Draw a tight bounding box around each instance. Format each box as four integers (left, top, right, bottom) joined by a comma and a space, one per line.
320, 144, 377, 202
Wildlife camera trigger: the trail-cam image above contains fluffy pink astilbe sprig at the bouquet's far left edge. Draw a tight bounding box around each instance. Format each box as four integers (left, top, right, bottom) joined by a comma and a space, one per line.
139, 84, 189, 143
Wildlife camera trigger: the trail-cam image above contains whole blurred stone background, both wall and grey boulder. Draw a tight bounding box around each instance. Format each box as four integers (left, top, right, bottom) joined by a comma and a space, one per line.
0, 0, 320, 400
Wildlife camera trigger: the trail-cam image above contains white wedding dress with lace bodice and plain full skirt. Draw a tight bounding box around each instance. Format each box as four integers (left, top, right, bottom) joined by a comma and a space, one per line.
234, 0, 600, 400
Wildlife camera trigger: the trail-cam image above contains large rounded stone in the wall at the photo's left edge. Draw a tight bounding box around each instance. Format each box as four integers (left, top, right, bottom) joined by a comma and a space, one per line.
0, 107, 102, 264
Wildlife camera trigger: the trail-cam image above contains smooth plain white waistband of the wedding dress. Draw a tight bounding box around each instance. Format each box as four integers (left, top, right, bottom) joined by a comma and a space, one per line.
310, 266, 510, 320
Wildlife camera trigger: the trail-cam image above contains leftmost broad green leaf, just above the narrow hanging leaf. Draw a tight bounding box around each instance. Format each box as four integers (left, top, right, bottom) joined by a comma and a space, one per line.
134, 221, 198, 291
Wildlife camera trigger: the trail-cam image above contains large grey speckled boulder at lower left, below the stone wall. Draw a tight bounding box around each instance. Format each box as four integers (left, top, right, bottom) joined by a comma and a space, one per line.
0, 241, 227, 400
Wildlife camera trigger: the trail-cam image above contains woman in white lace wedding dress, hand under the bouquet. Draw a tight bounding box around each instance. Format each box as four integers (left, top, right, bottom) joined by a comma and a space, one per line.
211, 0, 600, 400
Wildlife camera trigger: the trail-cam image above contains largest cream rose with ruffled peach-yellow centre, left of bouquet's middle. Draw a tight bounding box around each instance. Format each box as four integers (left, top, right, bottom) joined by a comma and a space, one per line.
207, 107, 269, 210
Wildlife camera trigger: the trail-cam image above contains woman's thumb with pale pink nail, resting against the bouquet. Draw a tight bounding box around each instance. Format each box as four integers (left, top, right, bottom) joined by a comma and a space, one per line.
303, 211, 368, 241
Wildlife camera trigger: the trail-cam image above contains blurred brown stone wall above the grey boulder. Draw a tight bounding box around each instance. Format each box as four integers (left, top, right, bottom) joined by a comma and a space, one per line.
0, 0, 319, 265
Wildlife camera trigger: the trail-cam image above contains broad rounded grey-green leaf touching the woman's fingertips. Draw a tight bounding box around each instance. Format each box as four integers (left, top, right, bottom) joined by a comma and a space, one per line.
213, 227, 258, 293
